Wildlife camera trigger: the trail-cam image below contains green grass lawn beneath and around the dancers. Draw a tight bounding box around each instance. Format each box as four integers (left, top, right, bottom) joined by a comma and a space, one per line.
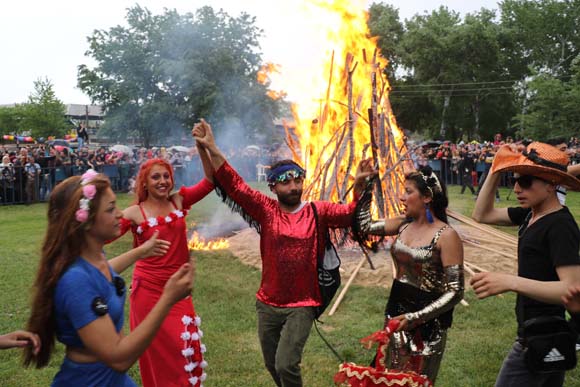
0, 187, 580, 387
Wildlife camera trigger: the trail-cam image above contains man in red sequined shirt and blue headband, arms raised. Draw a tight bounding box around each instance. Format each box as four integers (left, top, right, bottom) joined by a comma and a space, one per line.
193, 120, 374, 387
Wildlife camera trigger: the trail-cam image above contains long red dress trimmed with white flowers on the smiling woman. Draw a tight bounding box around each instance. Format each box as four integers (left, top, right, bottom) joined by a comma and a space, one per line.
122, 179, 214, 387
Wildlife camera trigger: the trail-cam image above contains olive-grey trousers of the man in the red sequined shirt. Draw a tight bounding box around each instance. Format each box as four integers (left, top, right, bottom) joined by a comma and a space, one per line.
256, 301, 314, 387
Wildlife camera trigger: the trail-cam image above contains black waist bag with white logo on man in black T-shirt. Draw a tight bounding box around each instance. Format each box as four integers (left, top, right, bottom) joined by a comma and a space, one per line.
523, 316, 578, 373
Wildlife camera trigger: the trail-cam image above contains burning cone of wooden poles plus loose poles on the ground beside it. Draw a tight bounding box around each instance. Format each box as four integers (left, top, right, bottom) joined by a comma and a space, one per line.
286, 50, 515, 315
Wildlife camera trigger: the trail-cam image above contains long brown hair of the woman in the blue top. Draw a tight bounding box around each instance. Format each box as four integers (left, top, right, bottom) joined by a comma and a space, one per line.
24, 174, 111, 368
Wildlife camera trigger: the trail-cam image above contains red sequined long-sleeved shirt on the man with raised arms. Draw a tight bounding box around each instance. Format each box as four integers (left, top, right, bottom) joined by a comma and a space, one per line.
214, 162, 356, 308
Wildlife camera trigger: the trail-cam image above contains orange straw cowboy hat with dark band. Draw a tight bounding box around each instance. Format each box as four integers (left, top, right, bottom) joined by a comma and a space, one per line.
490, 142, 580, 191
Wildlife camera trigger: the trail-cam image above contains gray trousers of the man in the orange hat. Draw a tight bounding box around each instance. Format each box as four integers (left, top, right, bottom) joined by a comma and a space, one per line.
495, 341, 566, 387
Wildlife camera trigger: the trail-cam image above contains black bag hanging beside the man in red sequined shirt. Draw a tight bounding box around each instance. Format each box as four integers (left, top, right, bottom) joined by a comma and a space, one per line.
310, 202, 340, 320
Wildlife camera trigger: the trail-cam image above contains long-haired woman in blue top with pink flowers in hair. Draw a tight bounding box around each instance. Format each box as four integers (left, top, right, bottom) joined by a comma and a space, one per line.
24, 170, 193, 387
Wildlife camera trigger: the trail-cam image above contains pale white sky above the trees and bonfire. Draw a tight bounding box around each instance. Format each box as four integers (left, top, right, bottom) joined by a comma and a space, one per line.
0, 0, 497, 105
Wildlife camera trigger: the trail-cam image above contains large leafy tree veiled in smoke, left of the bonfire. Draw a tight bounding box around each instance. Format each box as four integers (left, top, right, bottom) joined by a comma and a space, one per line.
78, 5, 278, 145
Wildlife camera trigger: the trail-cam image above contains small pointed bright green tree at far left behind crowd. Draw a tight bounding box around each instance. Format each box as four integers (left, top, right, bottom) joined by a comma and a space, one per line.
17, 78, 71, 137
